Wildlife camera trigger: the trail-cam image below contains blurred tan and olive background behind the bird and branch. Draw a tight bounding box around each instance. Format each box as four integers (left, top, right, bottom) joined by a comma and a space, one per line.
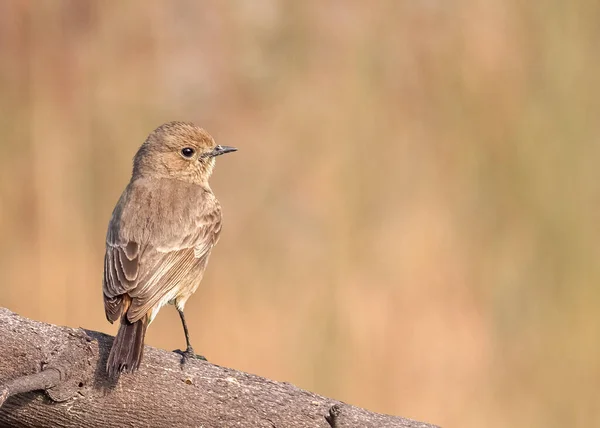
0, 0, 600, 427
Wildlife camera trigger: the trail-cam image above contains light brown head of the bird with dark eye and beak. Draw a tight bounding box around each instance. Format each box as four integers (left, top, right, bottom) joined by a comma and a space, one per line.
133, 122, 237, 184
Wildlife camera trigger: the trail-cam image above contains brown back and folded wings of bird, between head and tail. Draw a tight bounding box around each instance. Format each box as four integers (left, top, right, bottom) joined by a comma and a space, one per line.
103, 179, 221, 322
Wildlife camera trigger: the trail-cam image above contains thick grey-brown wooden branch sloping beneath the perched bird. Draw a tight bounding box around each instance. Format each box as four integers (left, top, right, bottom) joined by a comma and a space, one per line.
0, 308, 434, 428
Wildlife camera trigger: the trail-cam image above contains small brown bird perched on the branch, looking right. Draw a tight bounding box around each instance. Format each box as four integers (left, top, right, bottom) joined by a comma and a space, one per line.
102, 122, 237, 376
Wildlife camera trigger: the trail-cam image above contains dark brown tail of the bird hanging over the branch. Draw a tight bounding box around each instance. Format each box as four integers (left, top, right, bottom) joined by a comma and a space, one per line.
106, 313, 148, 377
